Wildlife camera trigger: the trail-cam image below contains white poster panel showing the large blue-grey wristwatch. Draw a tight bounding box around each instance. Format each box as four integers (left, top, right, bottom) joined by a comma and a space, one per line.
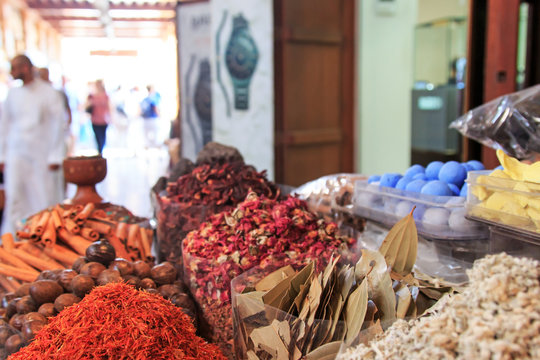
211, 0, 274, 179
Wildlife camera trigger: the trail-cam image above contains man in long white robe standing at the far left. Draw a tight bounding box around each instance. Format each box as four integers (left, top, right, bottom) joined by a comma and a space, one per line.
0, 55, 65, 233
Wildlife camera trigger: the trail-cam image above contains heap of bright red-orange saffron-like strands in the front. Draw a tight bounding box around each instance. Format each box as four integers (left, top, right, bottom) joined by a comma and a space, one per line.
9, 283, 226, 360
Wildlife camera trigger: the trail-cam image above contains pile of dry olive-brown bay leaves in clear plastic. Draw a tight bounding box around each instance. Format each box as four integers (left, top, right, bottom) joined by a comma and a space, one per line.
232, 210, 453, 360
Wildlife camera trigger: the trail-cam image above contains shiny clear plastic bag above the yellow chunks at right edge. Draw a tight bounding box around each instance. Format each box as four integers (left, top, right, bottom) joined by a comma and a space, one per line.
450, 85, 540, 159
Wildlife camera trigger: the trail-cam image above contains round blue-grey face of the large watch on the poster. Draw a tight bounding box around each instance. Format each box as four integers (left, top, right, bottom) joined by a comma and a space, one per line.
225, 29, 259, 79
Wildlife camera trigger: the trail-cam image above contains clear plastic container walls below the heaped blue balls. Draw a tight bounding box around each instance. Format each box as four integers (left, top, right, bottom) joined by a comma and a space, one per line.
353, 180, 488, 240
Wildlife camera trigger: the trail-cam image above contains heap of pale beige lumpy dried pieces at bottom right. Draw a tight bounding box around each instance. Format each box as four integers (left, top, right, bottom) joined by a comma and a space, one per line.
339, 253, 540, 360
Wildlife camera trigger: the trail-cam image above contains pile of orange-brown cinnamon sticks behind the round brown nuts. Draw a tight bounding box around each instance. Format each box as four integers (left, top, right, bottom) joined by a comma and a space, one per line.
0, 203, 153, 291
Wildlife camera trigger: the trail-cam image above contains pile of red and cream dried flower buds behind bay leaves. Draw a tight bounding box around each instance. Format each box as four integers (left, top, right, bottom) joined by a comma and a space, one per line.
184, 193, 353, 356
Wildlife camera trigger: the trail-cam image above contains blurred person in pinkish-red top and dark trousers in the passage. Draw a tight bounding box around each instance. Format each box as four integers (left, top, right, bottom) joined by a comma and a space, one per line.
85, 80, 111, 154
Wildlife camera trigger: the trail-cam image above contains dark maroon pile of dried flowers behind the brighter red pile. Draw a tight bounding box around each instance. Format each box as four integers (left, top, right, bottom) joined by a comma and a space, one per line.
156, 161, 280, 265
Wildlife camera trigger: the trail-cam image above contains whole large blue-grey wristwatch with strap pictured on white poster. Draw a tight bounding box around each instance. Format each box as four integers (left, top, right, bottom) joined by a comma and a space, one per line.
225, 14, 259, 110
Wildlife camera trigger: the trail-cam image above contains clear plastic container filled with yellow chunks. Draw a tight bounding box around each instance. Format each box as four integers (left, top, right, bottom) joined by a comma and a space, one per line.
466, 171, 540, 238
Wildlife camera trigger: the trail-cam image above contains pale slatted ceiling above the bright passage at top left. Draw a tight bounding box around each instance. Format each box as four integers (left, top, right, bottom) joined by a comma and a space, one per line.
25, 0, 177, 38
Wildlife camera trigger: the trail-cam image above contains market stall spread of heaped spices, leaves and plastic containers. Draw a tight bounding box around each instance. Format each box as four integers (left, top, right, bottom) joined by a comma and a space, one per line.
0, 117, 540, 359
